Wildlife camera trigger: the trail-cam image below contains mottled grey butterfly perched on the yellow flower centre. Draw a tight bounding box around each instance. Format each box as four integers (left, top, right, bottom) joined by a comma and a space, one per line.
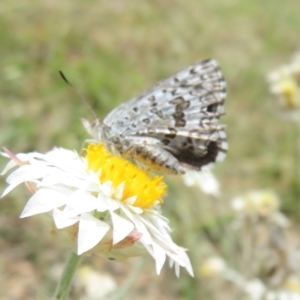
85, 59, 228, 174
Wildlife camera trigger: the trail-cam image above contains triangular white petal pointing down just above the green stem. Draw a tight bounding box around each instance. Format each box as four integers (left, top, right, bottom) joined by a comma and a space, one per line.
77, 213, 110, 255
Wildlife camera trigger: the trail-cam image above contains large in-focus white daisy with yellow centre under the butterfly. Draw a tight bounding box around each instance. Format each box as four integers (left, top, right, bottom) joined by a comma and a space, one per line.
2, 143, 193, 276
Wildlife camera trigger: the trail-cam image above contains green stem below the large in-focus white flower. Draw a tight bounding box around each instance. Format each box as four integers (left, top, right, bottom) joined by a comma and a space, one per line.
53, 252, 81, 300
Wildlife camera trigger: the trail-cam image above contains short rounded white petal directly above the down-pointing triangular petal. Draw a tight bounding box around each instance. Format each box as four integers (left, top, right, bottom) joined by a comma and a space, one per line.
63, 190, 97, 218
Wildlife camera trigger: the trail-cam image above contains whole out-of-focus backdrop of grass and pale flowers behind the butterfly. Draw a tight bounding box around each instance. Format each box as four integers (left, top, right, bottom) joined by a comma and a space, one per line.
0, 0, 300, 300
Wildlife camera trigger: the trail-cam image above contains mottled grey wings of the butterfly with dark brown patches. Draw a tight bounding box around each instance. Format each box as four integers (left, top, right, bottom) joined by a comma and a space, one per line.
104, 59, 228, 170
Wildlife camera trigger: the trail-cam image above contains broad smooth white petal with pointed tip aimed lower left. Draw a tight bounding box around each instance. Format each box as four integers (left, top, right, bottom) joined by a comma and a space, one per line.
20, 187, 71, 218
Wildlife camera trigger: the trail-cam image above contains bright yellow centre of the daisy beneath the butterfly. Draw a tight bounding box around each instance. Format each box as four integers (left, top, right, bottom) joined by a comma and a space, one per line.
86, 143, 167, 209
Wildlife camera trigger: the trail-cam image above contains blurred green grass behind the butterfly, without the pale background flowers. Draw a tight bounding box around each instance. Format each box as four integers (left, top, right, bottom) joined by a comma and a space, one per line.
0, 0, 300, 299
